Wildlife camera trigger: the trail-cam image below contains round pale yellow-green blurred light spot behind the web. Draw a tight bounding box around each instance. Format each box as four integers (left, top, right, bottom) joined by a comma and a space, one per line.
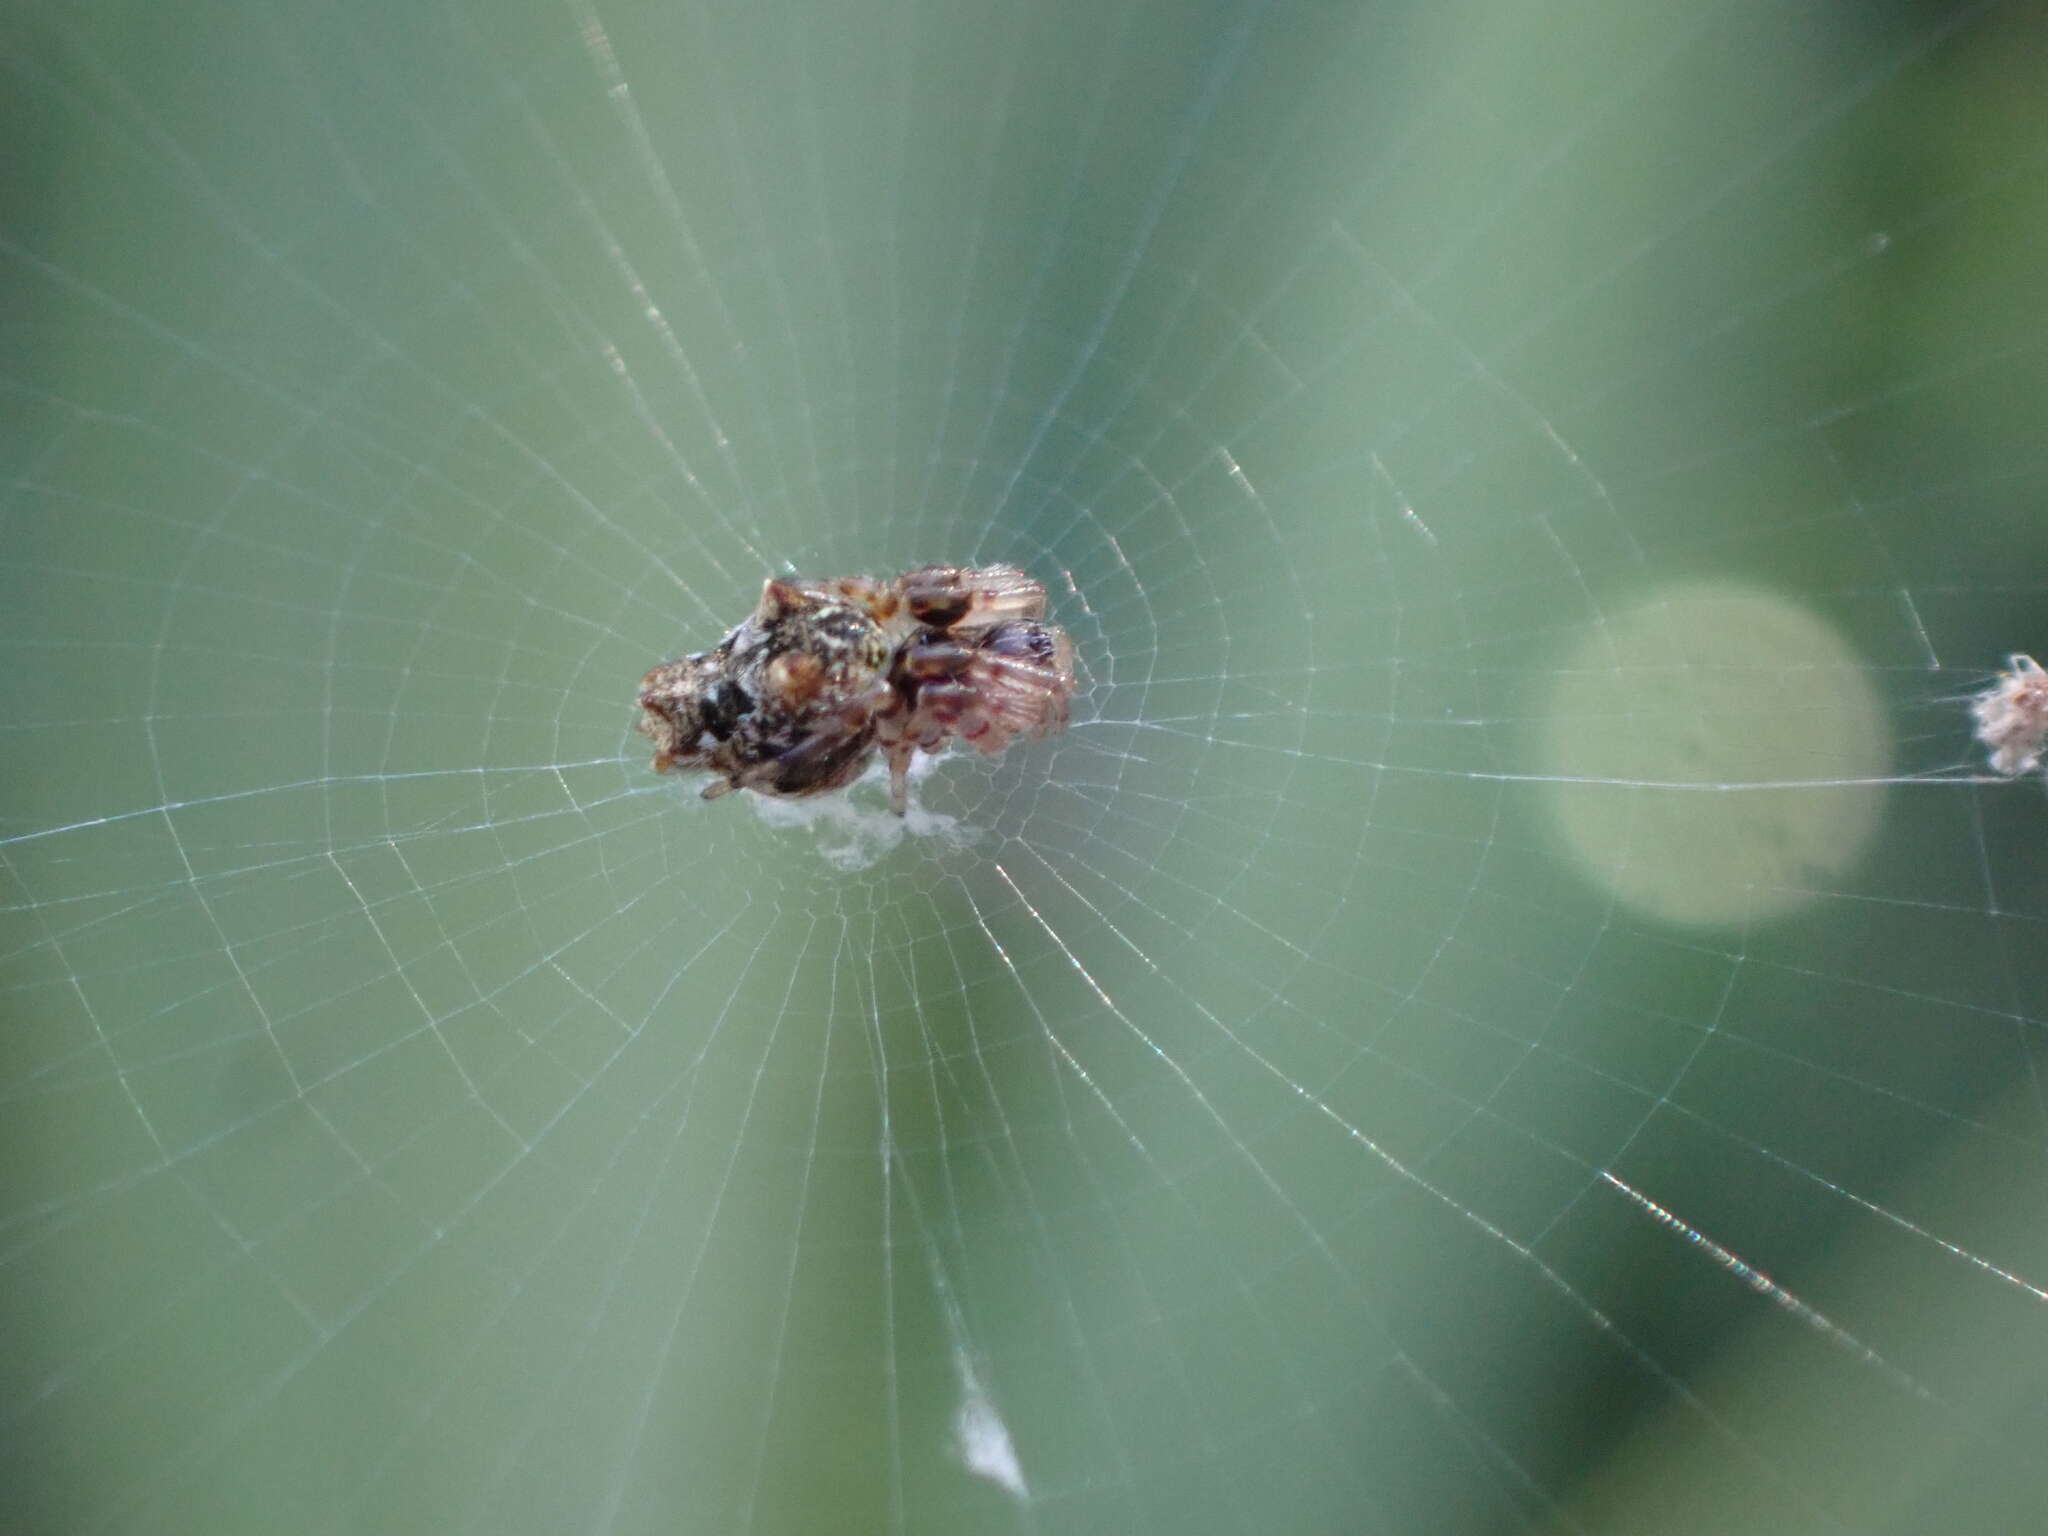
1538, 582, 1890, 926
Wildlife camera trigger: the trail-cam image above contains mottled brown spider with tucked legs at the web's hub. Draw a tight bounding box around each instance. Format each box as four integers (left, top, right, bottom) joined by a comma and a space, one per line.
639, 565, 1073, 815
